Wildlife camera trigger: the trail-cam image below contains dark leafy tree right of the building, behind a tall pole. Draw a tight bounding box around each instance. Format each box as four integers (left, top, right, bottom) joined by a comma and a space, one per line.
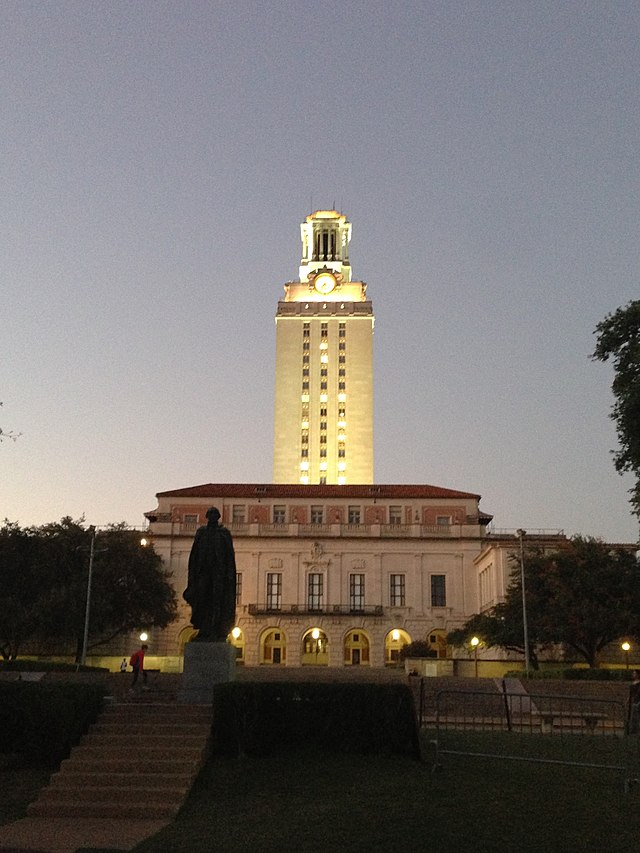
448, 536, 640, 667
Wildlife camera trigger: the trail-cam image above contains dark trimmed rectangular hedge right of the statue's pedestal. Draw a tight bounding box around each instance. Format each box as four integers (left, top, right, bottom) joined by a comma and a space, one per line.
212, 682, 420, 758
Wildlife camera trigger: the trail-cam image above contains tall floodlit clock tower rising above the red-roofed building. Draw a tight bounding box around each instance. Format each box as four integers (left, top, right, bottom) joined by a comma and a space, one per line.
273, 210, 374, 485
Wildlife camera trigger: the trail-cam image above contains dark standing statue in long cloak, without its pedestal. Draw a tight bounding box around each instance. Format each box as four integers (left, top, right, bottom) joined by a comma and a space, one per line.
182, 506, 236, 643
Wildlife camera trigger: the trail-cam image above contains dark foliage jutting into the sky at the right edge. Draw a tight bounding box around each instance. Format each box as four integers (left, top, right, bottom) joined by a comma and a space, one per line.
592, 300, 640, 517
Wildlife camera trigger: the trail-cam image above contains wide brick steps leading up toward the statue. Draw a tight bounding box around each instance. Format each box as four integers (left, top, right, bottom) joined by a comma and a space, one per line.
28, 703, 211, 820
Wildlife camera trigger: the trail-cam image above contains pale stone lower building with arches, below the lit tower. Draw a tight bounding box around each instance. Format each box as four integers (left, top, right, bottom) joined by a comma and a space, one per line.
146, 483, 490, 667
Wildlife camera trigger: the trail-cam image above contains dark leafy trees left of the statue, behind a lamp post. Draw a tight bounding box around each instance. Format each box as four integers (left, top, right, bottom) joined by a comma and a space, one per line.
0, 518, 177, 659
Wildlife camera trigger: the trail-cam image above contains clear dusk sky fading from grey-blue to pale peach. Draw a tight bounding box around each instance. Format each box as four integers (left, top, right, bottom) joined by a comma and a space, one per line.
0, 0, 640, 541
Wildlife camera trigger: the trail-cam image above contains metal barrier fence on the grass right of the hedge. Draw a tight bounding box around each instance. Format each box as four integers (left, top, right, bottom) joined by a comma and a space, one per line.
420, 679, 640, 792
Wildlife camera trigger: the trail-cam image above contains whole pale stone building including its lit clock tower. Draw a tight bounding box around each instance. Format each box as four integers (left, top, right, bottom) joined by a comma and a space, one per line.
141, 210, 560, 669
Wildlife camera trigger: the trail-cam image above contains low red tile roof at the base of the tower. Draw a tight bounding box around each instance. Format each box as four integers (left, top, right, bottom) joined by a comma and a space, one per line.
156, 483, 480, 501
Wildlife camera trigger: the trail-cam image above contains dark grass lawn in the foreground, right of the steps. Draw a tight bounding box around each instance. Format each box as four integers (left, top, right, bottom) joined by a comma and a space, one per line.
136, 734, 640, 853
